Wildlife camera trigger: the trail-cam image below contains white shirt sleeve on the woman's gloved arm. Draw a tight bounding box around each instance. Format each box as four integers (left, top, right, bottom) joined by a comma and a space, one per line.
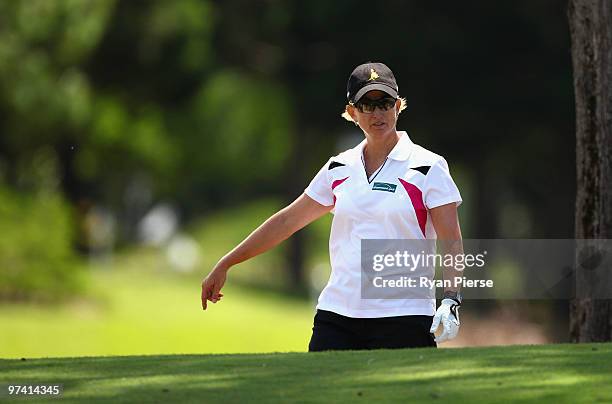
423, 159, 463, 209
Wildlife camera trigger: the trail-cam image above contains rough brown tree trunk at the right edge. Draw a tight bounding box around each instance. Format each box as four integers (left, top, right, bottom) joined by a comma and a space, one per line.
568, 0, 612, 342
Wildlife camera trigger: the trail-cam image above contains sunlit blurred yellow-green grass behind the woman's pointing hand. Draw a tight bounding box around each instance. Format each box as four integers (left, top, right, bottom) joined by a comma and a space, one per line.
0, 200, 329, 358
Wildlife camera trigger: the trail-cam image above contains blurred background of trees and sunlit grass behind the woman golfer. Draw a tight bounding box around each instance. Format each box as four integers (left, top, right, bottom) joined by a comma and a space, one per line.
0, 0, 575, 357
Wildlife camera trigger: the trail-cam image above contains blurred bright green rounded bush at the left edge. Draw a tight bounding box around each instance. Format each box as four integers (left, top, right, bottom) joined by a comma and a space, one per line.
0, 187, 85, 301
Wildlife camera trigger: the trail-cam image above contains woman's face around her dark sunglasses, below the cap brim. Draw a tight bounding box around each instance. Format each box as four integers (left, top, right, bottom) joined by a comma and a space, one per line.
346, 90, 401, 137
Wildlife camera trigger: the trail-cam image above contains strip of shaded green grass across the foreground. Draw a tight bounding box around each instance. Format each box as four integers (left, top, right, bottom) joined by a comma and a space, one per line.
0, 344, 612, 403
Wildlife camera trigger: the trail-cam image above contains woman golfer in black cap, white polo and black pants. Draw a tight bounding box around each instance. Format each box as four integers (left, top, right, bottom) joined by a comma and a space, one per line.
202, 63, 462, 351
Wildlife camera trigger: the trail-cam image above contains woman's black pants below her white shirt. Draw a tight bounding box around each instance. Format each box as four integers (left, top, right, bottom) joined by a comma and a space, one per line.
308, 310, 437, 352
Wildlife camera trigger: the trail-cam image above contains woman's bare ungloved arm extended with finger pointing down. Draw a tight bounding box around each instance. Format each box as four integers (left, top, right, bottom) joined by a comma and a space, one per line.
202, 194, 333, 310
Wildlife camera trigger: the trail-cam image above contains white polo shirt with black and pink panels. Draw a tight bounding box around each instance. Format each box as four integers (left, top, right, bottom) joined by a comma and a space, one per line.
304, 132, 462, 318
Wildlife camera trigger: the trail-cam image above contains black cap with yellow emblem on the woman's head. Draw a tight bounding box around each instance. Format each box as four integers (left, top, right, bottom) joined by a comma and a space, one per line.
346, 63, 399, 103
